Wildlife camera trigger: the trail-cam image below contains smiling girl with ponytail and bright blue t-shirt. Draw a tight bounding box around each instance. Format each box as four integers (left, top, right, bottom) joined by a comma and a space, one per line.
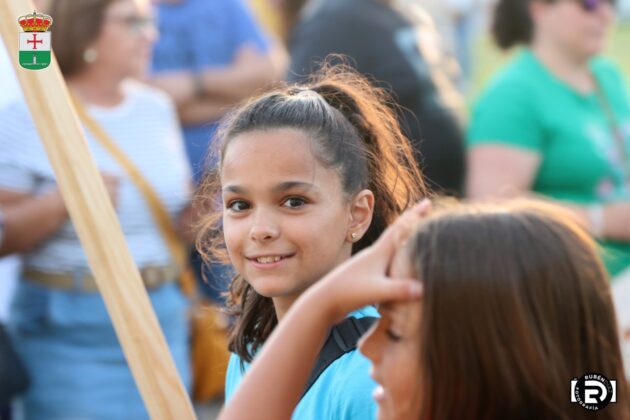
198, 65, 425, 420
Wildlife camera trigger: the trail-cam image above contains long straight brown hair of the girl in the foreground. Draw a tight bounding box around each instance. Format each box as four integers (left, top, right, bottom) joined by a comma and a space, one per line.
409, 201, 628, 420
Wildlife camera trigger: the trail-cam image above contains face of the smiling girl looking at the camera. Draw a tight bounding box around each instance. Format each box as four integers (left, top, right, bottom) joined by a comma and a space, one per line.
221, 129, 371, 316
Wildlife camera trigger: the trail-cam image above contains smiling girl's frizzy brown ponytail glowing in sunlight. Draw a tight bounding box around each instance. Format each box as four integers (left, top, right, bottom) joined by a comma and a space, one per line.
312, 66, 427, 252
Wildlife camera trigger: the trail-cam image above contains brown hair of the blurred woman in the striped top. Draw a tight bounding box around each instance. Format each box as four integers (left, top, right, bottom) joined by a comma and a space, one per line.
48, 0, 118, 77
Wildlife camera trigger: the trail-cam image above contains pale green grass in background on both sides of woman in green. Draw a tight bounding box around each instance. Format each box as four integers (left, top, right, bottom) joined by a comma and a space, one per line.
469, 22, 630, 99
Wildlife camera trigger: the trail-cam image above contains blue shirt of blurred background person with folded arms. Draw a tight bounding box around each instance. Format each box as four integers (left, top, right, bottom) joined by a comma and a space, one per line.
152, 0, 269, 182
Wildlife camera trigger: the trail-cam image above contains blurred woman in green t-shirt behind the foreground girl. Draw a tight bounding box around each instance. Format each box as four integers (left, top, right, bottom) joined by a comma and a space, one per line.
467, 0, 630, 281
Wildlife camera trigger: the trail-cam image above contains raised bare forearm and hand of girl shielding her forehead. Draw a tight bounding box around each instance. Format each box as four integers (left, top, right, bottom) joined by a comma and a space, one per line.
219, 201, 429, 420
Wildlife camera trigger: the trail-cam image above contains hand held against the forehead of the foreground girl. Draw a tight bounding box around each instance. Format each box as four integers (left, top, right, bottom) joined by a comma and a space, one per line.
304, 200, 431, 323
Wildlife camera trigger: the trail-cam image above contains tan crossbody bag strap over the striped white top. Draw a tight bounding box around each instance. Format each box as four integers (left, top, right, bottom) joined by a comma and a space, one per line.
72, 97, 196, 295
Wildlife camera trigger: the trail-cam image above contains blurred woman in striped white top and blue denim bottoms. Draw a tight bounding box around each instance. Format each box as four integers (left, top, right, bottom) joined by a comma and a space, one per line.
0, 0, 190, 419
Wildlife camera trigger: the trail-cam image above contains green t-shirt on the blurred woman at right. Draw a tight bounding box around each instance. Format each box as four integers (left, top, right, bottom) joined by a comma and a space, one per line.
467, 49, 630, 276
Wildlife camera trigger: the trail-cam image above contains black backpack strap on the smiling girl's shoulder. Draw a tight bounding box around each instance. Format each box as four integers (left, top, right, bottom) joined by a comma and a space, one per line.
302, 316, 377, 397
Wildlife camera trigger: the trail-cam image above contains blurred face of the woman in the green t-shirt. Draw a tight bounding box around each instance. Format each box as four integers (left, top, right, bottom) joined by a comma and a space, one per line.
533, 0, 614, 60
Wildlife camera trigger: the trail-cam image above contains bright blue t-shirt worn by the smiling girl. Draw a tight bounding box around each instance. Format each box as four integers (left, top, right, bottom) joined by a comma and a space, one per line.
225, 307, 379, 420
